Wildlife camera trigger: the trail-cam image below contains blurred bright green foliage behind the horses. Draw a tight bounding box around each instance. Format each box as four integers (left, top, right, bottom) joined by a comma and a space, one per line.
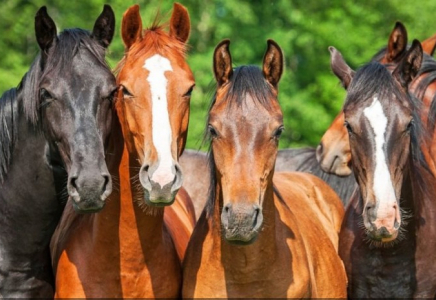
0, 0, 436, 148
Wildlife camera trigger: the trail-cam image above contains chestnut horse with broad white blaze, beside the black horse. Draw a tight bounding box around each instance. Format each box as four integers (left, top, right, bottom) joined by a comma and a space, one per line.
52, 3, 195, 298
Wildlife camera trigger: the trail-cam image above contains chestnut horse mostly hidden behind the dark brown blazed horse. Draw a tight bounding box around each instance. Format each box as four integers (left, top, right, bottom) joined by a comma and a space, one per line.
316, 22, 436, 176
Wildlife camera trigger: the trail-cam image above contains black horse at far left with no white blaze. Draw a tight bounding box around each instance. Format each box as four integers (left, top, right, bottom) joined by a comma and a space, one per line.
0, 6, 116, 298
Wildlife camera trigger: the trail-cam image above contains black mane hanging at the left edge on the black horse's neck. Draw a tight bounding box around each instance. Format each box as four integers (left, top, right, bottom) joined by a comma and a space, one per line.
0, 88, 18, 183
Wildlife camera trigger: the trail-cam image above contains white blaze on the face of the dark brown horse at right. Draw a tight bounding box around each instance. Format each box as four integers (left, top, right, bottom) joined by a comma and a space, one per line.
363, 97, 396, 217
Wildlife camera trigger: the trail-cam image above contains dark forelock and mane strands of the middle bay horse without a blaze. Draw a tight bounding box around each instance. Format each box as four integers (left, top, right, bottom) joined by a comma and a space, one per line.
205, 66, 273, 217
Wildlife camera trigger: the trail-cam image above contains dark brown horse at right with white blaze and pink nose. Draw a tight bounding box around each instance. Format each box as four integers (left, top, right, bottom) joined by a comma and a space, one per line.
330, 40, 436, 298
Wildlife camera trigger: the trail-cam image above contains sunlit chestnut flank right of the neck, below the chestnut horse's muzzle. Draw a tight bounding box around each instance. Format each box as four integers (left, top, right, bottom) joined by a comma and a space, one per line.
164, 188, 195, 261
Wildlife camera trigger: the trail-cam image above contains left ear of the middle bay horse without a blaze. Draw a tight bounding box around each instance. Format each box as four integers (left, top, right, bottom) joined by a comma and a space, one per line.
213, 39, 233, 87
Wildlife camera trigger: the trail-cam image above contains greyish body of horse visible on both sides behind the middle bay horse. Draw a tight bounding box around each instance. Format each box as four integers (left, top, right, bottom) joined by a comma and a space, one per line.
180, 147, 356, 219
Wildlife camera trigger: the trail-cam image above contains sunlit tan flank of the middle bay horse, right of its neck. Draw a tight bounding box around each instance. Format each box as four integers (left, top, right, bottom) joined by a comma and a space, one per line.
274, 172, 347, 298
